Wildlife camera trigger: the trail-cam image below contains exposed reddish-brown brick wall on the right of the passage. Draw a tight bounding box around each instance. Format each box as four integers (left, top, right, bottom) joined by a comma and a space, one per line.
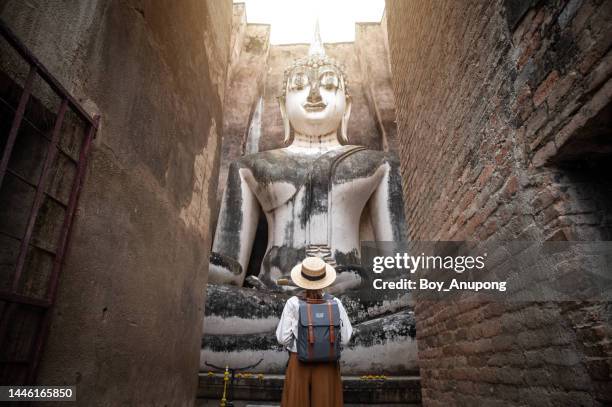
387, 0, 612, 405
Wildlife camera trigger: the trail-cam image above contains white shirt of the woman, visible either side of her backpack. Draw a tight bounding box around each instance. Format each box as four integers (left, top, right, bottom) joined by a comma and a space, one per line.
276, 296, 353, 352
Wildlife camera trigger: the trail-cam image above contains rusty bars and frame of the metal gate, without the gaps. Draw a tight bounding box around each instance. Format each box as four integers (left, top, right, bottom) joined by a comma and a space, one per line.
0, 20, 100, 384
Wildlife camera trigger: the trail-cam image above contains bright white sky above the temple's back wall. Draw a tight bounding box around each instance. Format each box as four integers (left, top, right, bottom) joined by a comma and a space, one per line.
234, 0, 385, 44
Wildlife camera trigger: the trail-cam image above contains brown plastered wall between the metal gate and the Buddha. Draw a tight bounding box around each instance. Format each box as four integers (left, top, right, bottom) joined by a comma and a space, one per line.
0, 0, 232, 406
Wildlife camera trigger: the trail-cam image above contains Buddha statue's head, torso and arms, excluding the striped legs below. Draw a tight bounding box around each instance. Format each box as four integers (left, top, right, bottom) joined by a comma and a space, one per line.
209, 27, 405, 293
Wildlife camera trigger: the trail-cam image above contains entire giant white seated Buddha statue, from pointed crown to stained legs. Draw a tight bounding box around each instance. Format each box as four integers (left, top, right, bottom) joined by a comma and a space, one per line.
201, 23, 418, 380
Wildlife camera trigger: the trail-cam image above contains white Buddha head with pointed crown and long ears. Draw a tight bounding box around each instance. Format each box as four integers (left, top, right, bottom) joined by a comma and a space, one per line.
279, 24, 351, 143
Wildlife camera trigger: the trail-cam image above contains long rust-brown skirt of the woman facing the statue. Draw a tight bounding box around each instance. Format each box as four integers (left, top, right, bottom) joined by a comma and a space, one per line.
281, 352, 343, 407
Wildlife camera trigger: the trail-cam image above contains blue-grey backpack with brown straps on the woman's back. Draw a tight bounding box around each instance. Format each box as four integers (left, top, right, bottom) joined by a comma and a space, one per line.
297, 294, 340, 362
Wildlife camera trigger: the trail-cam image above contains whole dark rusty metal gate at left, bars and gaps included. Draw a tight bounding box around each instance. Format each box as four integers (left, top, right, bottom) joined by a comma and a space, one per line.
0, 21, 99, 385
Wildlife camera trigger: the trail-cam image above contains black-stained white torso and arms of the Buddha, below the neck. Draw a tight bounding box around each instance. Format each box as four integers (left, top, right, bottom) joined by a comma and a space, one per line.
209, 146, 405, 292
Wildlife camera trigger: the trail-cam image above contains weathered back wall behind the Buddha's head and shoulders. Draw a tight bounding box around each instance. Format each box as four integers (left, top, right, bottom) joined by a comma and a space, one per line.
215, 3, 397, 275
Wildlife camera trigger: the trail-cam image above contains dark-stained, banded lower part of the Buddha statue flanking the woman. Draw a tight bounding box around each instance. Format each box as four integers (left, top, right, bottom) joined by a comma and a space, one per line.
200, 284, 418, 375
